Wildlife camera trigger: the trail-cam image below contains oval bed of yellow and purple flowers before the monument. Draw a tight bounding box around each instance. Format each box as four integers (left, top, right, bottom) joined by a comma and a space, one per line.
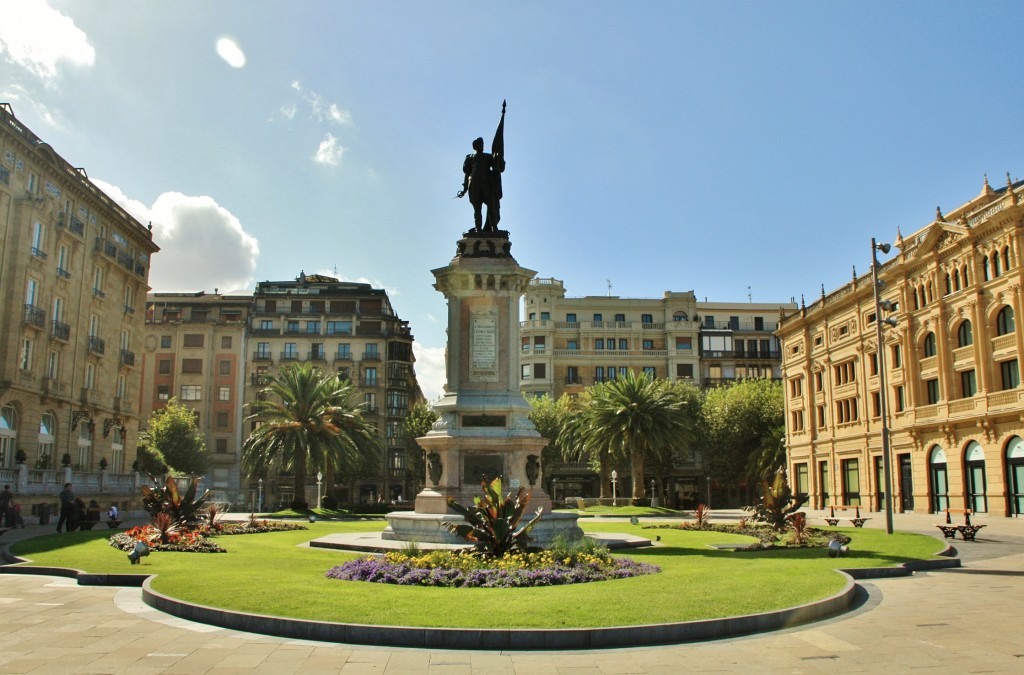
327, 551, 662, 588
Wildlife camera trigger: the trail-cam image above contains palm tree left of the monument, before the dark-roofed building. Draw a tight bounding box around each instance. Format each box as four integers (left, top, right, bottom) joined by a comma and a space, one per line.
242, 364, 381, 509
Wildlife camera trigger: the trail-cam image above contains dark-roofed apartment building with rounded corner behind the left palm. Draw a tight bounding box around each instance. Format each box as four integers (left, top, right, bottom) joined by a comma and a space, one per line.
245, 273, 424, 504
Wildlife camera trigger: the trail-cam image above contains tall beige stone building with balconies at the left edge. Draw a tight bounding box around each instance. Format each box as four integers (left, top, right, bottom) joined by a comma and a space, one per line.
0, 103, 159, 509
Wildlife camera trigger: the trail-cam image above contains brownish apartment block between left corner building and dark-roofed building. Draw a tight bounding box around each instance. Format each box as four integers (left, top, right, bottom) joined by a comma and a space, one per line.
139, 290, 252, 504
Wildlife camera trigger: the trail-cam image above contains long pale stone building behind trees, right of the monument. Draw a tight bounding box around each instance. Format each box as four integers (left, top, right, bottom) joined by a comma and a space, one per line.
520, 279, 797, 504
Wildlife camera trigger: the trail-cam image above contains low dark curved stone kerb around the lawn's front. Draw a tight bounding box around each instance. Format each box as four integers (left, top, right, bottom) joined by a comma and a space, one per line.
0, 546, 961, 650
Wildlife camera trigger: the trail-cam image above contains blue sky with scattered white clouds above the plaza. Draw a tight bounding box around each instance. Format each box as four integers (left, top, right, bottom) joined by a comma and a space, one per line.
0, 0, 1024, 397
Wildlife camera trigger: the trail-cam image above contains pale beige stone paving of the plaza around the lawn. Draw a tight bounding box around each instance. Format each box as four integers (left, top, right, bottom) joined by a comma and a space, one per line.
0, 512, 1024, 675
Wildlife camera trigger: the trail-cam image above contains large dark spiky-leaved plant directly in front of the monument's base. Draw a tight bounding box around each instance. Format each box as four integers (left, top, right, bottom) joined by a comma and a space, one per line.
441, 478, 542, 557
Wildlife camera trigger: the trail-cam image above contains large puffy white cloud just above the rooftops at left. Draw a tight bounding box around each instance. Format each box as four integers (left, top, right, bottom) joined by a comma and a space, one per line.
92, 179, 259, 292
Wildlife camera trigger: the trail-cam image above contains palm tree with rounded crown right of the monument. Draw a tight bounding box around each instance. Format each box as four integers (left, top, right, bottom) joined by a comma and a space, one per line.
581, 372, 693, 500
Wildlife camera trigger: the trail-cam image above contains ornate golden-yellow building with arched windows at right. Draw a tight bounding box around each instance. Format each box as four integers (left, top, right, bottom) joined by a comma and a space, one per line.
777, 176, 1024, 516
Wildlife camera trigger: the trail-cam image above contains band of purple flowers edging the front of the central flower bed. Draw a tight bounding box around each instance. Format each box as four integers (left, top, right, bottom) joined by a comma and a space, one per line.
327, 558, 662, 588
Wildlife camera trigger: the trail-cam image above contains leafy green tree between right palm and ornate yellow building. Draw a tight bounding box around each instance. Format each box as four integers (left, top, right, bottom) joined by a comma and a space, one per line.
703, 379, 784, 499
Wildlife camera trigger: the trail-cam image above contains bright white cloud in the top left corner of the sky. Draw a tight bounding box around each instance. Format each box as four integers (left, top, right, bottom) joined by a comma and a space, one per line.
0, 0, 96, 84
